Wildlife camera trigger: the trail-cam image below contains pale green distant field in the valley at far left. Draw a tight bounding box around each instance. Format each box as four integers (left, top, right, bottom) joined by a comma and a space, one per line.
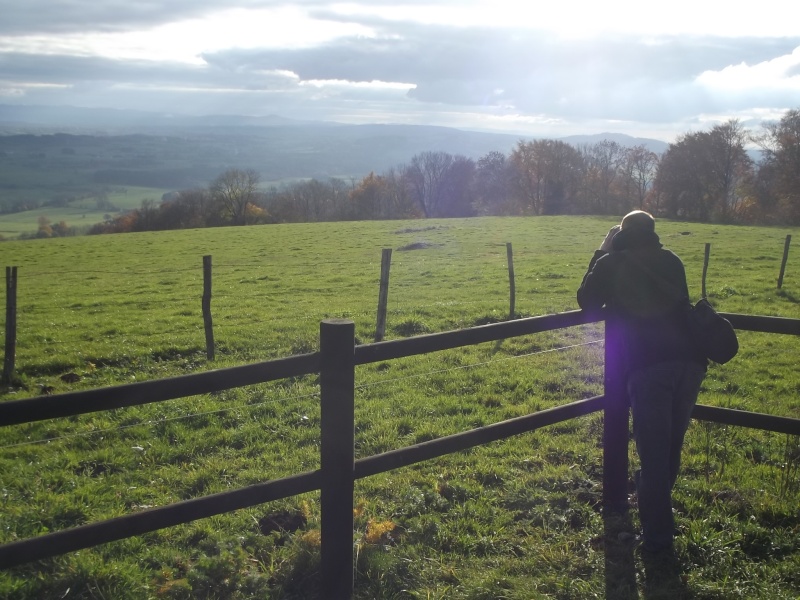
0, 187, 168, 238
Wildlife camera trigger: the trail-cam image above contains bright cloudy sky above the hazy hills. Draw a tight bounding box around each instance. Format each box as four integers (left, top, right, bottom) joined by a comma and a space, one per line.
0, 0, 800, 142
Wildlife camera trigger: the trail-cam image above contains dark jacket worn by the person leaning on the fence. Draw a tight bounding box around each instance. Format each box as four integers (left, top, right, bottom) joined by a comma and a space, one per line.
578, 228, 706, 372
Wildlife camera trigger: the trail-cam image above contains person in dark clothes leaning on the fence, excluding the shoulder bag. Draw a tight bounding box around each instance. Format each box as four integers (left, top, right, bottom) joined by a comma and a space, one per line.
577, 210, 707, 552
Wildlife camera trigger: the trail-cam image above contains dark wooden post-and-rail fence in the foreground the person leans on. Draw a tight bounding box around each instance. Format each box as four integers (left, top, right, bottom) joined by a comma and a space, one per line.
0, 311, 800, 599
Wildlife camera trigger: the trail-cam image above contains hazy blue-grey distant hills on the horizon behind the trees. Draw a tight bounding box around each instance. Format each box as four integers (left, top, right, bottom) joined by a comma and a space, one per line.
0, 104, 667, 200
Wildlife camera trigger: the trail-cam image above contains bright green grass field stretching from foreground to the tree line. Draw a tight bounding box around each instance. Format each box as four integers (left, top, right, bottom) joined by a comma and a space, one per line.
0, 217, 800, 600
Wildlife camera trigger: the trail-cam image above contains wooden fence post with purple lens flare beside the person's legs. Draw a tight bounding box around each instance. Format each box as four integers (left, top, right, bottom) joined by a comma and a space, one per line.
603, 316, 628, 513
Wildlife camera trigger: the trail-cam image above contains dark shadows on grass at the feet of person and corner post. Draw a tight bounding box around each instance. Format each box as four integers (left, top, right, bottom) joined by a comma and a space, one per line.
603, 512, 695, 600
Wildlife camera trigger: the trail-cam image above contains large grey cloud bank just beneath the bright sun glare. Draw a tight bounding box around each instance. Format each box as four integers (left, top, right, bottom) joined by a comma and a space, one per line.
197, 23, 797, 121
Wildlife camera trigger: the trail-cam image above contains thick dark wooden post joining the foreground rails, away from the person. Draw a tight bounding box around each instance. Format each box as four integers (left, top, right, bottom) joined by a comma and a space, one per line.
319, 319, 356, 600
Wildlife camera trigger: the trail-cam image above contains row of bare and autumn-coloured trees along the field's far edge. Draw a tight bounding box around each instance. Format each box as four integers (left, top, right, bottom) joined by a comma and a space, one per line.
90, 109, 800, 233
